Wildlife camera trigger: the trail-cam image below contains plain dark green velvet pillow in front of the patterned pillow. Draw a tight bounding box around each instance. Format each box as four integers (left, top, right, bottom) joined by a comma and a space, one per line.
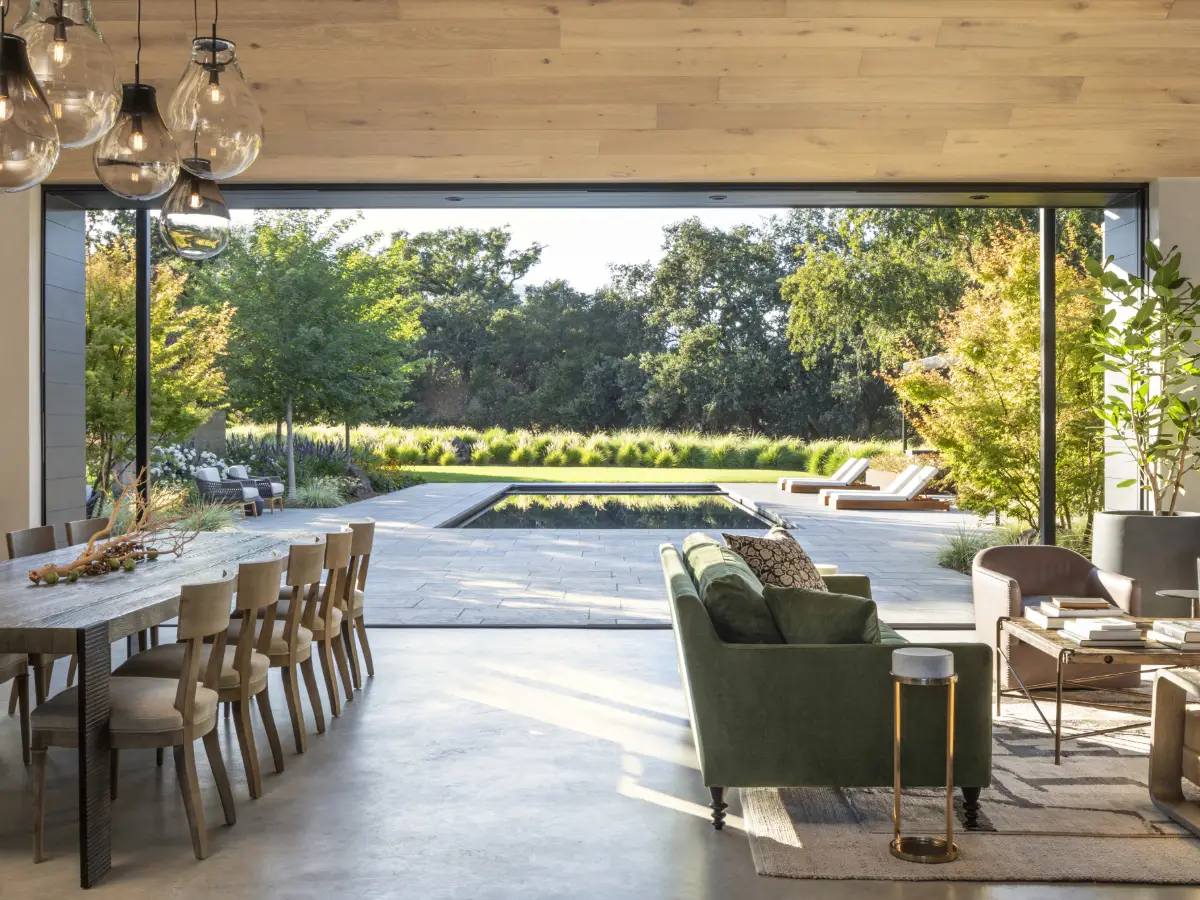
762, 584, 880, 644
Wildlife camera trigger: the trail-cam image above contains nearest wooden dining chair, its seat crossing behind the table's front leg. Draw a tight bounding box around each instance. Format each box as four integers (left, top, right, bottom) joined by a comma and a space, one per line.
31, 577, 236, 863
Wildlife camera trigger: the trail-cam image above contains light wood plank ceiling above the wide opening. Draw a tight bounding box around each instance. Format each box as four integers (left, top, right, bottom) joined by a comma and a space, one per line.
42, 0, 1200, 182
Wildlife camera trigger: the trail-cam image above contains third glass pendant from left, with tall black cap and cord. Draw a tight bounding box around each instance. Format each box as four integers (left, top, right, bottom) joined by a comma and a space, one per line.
92, 0, 179, 200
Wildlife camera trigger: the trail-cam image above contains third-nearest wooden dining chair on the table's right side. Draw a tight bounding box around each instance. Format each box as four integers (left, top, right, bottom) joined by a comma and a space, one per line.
253, 539, 325, 754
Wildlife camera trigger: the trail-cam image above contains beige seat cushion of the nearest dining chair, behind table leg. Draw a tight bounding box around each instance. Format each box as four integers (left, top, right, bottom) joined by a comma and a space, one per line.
30, 677, 217, 734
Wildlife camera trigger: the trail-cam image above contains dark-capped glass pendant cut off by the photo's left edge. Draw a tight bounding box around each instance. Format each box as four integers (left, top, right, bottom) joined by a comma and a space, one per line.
0, 0, 60, 193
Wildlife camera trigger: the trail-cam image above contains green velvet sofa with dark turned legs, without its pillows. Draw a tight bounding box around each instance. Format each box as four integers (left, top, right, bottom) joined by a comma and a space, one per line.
660, 544, 991, 828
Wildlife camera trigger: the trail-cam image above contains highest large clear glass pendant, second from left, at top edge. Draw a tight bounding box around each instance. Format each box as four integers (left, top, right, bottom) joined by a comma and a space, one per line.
16, 0, 121, 148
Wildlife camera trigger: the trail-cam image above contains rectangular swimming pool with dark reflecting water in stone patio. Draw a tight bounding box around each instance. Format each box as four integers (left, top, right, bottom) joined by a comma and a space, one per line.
446, 485, 772, 530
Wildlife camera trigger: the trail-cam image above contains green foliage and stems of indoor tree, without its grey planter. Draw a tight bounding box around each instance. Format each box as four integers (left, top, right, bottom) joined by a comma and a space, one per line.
1085, 242, 1200, 516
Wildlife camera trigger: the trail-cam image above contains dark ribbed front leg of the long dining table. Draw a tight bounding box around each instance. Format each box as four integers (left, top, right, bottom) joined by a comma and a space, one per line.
76, 623, 113, 888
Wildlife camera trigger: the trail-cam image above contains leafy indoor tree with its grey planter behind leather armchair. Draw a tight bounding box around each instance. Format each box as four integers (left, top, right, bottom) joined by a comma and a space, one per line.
1086, 242, 1200, 616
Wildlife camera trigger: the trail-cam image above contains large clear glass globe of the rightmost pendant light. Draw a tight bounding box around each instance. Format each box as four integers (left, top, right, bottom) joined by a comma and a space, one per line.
167, 36, 263, 181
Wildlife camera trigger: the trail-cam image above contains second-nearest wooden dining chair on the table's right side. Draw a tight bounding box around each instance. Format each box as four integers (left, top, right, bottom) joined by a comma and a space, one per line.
113, 557, 283, 800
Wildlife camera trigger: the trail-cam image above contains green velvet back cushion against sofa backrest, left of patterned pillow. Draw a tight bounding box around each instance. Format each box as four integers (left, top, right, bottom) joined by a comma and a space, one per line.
684, 539, 784, 643
